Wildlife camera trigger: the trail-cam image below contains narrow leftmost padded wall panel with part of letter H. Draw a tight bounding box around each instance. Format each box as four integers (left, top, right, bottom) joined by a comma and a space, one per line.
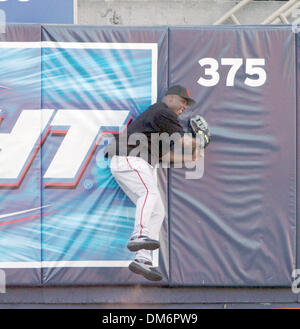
0, 25, 42, 285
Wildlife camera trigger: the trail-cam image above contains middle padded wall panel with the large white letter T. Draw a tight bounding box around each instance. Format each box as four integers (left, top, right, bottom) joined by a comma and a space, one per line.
42, 26, 168, 285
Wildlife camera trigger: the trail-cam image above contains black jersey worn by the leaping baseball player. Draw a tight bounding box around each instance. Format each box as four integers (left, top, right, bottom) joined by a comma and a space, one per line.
104, 103, 184, 165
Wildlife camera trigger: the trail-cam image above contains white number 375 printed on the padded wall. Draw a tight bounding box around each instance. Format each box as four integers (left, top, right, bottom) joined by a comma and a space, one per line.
198, 57, 267, 87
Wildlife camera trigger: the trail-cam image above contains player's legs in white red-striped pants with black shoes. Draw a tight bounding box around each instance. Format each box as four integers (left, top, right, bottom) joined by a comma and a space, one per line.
111, 157, 164, 281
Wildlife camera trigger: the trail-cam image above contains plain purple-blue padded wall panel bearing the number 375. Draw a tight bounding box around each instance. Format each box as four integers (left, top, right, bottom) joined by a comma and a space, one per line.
169, 26, 296, 286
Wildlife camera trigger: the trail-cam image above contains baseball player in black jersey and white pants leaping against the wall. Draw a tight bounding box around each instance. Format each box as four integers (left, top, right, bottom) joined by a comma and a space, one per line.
105, 85, 210, 281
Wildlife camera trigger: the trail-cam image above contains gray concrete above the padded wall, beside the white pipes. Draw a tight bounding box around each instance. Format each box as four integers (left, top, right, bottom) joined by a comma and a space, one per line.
78, 0, 295, 26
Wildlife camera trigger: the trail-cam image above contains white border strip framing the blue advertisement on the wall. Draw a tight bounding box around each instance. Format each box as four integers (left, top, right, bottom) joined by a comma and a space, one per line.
0, 40, 159, 269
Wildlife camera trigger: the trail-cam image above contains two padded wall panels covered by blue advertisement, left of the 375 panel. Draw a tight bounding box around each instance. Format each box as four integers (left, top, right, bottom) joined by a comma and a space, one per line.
0, 25, 169, 285
